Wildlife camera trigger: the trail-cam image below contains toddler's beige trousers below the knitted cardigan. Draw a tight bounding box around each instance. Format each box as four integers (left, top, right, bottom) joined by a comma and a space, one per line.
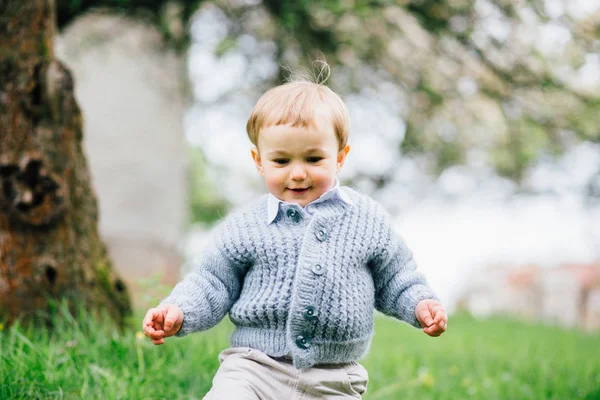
204, 347, 369, 400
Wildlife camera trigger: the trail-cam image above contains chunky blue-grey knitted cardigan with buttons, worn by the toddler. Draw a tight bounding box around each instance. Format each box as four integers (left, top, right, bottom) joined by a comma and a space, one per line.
161, 187, 437, 368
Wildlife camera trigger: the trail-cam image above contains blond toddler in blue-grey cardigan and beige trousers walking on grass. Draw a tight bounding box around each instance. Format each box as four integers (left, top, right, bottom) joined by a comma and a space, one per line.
143, 70, 447, 400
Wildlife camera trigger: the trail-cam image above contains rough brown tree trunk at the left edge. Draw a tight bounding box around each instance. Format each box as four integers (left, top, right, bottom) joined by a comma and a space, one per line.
0, 0, 130, 324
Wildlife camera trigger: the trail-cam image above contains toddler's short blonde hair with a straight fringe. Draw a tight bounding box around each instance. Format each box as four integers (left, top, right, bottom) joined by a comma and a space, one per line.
246, 78, 349, 150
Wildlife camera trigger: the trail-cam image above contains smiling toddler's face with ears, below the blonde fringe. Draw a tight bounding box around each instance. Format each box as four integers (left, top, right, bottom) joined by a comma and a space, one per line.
252, 113, 350, 207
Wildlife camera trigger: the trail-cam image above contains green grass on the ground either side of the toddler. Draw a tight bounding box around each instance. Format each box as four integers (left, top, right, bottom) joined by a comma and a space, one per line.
0, 313, 600, 400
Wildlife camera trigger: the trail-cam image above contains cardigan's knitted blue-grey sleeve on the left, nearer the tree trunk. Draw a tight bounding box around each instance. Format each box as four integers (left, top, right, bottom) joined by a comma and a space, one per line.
161, 214, 250, 336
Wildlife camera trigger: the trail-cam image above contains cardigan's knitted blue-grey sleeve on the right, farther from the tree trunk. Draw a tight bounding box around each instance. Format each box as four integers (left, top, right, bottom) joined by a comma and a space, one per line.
370, 205, 438, 328
